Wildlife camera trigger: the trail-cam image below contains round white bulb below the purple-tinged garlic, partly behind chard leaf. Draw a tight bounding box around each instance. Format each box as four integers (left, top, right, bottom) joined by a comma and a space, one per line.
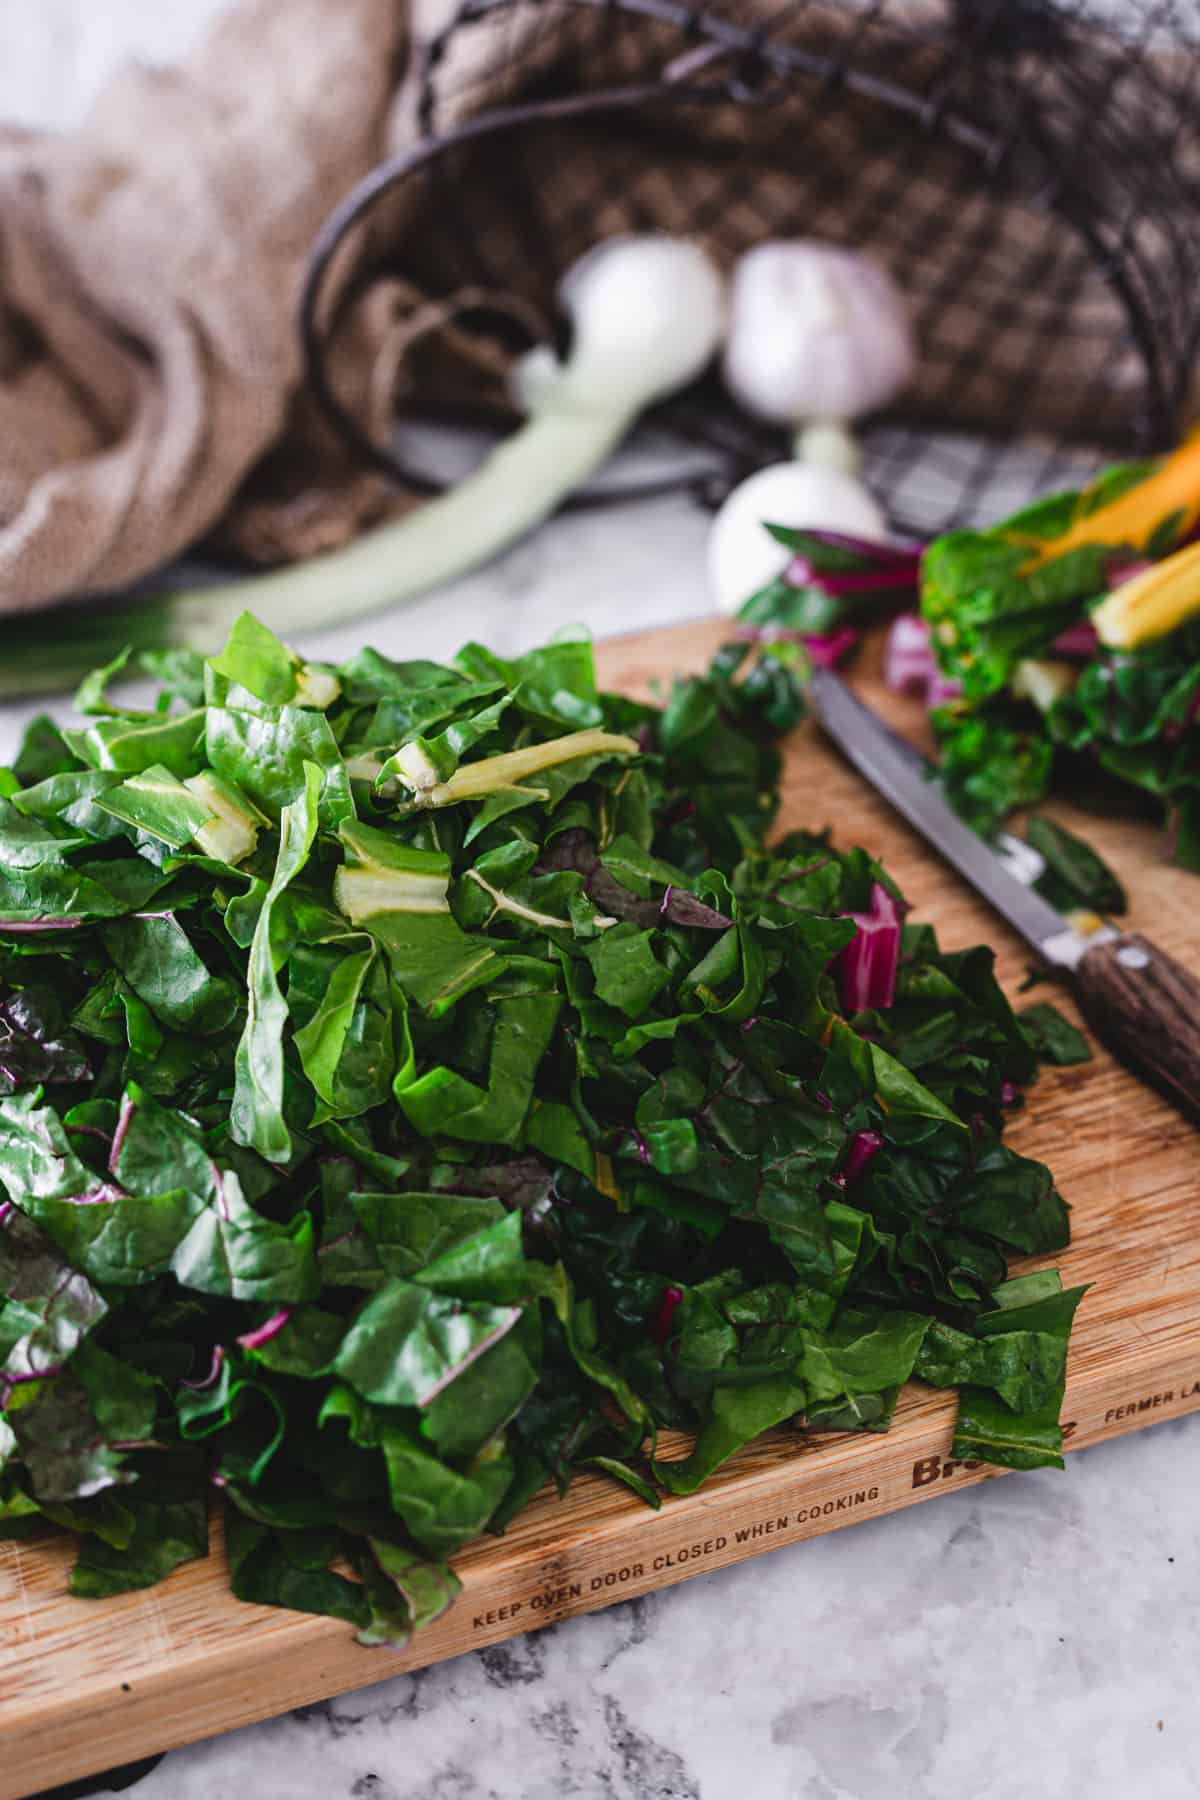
709, 463, 887, 612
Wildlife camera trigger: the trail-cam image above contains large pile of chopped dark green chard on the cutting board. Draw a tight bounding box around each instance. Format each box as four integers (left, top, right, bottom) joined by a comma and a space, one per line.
0, 621, 1074, 1643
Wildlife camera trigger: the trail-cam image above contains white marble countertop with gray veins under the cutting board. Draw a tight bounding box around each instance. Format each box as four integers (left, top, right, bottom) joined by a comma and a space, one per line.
0, 0, 1200, 1800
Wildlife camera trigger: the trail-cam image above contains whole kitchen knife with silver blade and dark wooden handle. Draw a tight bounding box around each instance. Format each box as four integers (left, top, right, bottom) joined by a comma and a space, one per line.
808, 668, 1200, 1121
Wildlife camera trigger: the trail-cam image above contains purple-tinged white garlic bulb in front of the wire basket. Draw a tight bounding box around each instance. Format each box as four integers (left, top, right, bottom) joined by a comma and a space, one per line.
725, 239, 916, 425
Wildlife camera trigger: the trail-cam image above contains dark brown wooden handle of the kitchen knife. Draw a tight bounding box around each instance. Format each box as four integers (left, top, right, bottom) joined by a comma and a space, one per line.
1076, 932, 1200, 1121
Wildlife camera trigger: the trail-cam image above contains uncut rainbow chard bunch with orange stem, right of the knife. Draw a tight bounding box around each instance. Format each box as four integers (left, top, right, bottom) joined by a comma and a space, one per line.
921, 457, 1200, 864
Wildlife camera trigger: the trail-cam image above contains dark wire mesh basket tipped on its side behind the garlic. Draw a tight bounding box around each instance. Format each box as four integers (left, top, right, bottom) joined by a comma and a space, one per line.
302, 0, 1200, 533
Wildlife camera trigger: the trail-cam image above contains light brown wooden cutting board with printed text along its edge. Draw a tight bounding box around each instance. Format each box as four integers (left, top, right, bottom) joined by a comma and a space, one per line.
0, 621, 1200, 1800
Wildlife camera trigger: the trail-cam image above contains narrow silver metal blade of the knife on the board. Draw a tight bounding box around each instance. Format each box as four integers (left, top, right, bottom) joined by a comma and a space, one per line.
808, 668, 1117, 968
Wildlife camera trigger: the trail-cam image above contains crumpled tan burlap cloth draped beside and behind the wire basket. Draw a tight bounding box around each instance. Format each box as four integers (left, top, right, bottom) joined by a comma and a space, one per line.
0, 0, 1173, 612
